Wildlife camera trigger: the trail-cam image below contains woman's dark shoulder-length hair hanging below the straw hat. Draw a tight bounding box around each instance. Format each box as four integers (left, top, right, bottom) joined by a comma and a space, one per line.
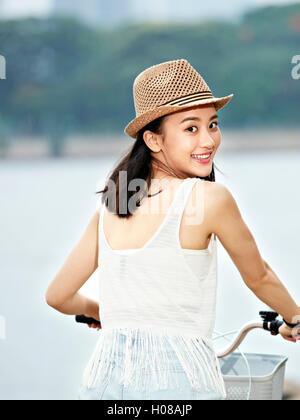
96, 116, 223, 218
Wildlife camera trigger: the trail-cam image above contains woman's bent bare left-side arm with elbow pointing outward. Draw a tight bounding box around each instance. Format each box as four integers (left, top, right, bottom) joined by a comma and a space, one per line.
46, 210, 99, 321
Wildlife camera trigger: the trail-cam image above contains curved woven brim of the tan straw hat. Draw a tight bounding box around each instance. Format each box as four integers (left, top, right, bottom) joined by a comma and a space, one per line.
124, 93, 233, 139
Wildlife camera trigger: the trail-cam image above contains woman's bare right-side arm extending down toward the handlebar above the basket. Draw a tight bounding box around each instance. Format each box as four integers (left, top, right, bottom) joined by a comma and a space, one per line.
205, 182, 300, 330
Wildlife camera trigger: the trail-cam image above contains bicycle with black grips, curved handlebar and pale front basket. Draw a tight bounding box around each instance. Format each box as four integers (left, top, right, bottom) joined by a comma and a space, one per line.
75, 311, 288, 400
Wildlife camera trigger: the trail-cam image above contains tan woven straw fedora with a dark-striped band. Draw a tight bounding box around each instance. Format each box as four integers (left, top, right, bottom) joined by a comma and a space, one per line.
124, 59, 233, 138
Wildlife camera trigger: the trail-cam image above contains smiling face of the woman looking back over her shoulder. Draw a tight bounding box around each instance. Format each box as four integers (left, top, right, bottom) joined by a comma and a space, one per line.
147, 104, 221, 177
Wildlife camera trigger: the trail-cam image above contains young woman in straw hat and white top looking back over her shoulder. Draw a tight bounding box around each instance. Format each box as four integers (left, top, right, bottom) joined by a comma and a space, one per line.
46, 59, 300, 400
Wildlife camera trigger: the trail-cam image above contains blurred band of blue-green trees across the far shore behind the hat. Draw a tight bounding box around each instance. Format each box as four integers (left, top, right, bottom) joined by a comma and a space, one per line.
0, 4, 300, 152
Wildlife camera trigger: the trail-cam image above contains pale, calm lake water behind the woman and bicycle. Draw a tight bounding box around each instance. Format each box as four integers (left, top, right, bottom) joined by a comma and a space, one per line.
0, 151, 300, 400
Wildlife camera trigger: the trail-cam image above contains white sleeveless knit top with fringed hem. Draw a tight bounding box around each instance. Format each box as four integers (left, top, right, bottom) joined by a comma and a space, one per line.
82, 178, 226, 397
